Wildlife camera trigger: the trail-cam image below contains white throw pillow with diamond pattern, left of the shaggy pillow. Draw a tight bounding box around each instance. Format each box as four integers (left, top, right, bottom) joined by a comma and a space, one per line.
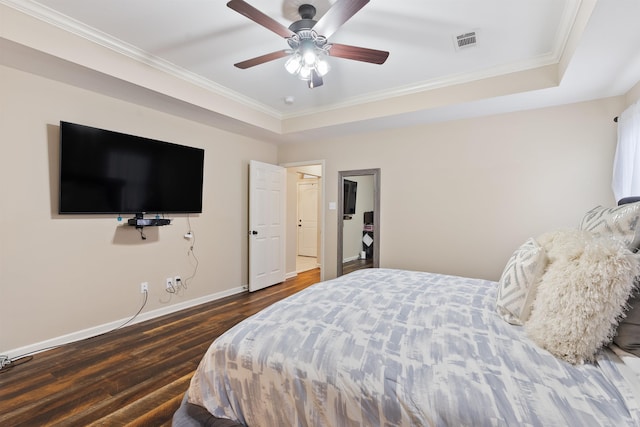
496, 238, 547, 325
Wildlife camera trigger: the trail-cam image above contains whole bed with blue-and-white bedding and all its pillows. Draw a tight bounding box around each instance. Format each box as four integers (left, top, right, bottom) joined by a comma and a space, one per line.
174, 203, 640, 427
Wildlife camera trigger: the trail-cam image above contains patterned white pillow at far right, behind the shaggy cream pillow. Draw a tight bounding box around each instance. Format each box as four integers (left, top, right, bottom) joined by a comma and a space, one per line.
580, 202, 640, 250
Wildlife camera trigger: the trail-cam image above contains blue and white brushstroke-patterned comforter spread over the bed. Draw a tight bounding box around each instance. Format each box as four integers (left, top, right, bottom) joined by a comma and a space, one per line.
188, 269, 640, 427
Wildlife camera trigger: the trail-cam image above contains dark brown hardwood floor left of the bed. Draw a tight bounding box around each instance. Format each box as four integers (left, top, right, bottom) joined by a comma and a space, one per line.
0, 269, 320, 427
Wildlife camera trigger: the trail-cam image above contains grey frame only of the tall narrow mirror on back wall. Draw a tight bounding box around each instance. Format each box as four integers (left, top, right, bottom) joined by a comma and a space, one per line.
336, 168, 380, 277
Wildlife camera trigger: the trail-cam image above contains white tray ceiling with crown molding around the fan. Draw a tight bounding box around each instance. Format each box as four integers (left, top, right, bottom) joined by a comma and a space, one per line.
0, 0, 640, 142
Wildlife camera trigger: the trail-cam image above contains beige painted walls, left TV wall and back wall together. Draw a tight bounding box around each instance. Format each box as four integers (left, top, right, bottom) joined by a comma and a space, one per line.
0, 60, 634, 356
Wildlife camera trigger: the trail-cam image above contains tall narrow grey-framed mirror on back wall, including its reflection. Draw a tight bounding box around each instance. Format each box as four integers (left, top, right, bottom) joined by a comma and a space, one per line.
337, 169, 380, 276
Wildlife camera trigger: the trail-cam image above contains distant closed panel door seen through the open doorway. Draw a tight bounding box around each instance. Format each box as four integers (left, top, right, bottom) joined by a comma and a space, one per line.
298, 182, 318, 257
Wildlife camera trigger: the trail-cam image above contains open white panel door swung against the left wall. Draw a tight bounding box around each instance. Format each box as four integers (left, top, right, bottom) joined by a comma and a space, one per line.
249, 160, 286, 292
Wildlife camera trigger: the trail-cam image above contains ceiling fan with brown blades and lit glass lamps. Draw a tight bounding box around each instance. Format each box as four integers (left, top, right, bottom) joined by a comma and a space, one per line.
227, 0, 389, 89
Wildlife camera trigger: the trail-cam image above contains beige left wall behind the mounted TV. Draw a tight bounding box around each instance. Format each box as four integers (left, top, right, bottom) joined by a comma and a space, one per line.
0, 67, 277, 356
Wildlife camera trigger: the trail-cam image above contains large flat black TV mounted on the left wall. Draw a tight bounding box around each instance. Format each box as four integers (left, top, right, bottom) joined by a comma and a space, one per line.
58, 121, 204, 214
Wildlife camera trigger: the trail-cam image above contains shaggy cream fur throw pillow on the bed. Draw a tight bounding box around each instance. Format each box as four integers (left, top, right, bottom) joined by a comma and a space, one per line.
525, 230, 640, 364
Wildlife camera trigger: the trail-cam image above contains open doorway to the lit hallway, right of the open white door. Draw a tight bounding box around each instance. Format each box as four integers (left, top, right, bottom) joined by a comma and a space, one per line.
281, 161, 324, 279
